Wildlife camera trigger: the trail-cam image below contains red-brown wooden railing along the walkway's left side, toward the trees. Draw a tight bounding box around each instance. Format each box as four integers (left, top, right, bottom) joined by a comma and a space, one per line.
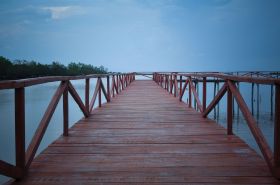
0, 73, 135, 179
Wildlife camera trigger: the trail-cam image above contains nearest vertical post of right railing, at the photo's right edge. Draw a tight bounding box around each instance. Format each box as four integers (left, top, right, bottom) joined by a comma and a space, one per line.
274, 84, 280, 168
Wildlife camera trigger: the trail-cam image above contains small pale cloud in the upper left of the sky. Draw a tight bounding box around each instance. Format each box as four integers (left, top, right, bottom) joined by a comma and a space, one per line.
42, 6, 86, 20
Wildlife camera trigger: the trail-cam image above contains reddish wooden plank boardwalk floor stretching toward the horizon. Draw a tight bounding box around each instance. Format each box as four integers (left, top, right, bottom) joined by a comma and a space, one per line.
14, 80, 279, 185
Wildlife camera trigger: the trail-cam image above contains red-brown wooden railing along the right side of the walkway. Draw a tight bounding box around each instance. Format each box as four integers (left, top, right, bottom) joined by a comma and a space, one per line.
153, 73, 280, 178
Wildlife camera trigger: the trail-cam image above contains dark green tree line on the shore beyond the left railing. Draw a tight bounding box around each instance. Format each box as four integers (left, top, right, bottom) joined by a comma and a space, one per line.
0, 56, 108, 80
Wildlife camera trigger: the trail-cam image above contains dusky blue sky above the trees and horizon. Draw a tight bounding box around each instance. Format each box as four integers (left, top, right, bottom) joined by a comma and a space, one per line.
0, 0, 280, 72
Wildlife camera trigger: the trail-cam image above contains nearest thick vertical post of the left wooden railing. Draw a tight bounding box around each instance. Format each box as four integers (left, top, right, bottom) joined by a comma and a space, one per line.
15, 87, 25, 178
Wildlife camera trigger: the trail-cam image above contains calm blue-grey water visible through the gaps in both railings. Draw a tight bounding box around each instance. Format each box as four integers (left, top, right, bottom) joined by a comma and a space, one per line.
0, 78, 274, 184
